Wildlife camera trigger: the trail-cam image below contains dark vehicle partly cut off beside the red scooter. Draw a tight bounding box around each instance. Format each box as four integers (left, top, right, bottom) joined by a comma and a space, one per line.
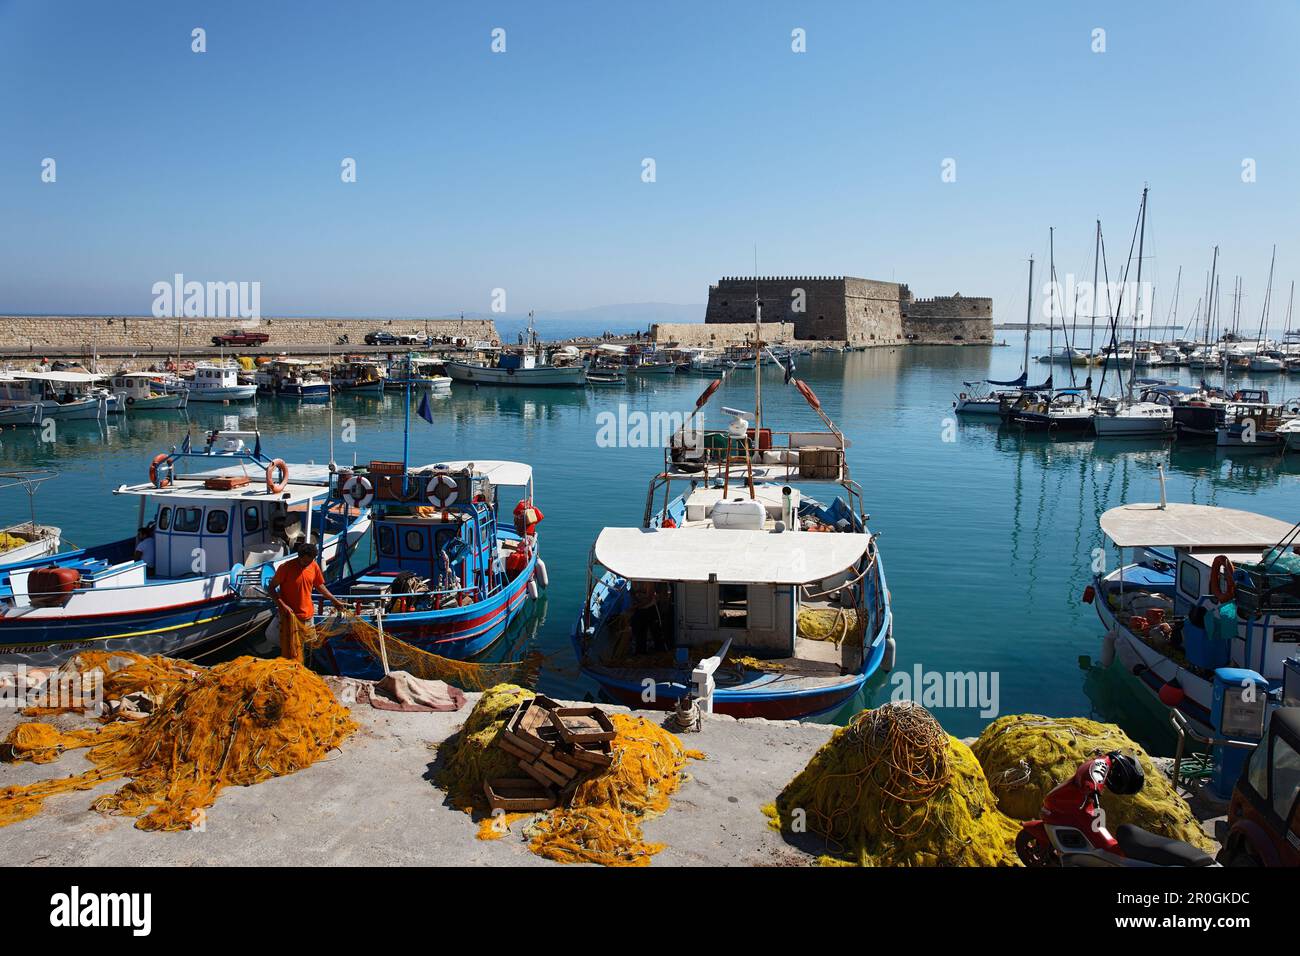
1218, 708, 1300, 866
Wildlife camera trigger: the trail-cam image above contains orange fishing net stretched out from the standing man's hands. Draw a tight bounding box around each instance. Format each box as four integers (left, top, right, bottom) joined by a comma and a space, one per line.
314, 611, 542, 691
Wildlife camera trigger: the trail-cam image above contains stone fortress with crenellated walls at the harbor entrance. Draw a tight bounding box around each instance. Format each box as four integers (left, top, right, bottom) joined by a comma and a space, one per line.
654, 276, 993, 346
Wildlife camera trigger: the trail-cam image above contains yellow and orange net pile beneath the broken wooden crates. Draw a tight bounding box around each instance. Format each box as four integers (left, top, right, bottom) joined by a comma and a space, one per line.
438, 684, 703, 866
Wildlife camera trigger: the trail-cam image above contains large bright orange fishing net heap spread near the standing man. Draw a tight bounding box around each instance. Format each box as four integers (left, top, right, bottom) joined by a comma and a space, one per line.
0, 653, 356, 830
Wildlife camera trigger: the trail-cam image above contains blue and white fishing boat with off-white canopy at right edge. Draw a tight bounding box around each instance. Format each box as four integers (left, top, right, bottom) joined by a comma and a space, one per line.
1084, 502, 1300, 732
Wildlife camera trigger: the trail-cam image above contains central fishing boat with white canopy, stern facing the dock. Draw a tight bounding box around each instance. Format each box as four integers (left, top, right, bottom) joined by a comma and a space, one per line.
572, 303, 894, 719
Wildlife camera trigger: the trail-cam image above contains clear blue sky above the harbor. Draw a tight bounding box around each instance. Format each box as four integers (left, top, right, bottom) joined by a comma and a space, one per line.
0, 0, 1300, 319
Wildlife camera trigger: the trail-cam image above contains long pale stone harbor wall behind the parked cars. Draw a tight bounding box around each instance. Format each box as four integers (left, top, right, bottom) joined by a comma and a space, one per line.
0, 315, 499, 355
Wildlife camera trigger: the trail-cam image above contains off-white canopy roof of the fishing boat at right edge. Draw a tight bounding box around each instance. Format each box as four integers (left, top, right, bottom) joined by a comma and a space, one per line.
1101, 503, 1295, 551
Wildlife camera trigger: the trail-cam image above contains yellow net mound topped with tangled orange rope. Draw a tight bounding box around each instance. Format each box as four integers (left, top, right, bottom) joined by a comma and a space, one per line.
770, 701, 1019, 866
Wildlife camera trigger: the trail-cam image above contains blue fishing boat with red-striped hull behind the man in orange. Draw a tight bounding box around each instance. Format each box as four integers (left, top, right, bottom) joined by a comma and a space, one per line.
316, 460, 546, 676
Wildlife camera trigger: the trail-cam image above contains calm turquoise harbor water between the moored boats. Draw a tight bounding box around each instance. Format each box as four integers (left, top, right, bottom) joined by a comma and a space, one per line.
0, 334, 1300, 749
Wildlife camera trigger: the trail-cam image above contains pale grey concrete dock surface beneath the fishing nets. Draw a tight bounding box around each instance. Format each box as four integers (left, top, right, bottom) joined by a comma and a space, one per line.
0, 695, 835, 866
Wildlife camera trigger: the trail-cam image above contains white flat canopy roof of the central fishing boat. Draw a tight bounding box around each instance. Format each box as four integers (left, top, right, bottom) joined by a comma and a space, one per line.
595, 528, 871, 584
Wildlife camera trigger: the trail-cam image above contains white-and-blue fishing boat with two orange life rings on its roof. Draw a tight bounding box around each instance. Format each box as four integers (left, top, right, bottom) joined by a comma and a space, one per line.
0, 432, 371, 665
